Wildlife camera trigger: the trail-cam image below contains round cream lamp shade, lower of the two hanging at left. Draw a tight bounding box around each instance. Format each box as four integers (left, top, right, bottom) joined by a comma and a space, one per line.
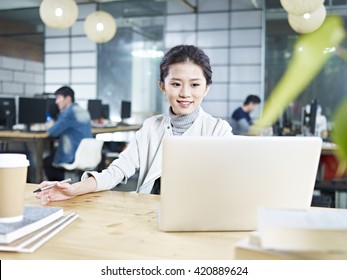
84, 11, 117, 43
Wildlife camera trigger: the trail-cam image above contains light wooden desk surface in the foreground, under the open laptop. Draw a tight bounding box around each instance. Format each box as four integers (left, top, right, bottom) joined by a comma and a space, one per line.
0, 184, 249, 260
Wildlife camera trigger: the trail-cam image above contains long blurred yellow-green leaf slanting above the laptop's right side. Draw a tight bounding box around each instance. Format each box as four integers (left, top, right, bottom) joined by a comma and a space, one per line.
255, 16, 345, 129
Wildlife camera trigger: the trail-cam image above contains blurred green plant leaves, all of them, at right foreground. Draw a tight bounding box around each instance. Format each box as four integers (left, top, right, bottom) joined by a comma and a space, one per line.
251, 15, 347, 174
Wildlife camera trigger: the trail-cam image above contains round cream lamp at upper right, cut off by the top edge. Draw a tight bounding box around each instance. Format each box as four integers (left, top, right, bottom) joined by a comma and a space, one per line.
281, 0, 324, 16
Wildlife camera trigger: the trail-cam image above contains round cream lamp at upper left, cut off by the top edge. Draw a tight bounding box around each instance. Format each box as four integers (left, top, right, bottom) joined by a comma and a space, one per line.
40, 0, 78, 29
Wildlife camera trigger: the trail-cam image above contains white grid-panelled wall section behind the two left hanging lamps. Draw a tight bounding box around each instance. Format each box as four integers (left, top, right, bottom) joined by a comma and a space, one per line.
45, 4, 97, 106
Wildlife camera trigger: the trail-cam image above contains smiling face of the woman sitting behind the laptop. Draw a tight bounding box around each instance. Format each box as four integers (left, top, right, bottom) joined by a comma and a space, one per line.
159, 62, 209, 115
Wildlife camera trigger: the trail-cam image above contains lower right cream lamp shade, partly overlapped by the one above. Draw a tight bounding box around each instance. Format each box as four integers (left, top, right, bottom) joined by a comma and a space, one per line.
288, 5, 326, 33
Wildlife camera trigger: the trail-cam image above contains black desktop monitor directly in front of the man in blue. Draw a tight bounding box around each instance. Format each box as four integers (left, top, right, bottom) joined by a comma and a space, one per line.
18, 97, 47, 130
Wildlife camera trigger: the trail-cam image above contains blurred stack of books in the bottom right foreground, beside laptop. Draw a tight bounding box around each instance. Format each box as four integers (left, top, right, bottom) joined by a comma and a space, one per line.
235, 208, 347, 259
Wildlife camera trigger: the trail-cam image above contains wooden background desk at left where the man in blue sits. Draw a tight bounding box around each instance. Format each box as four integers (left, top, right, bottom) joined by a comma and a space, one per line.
0, 125, 141, 183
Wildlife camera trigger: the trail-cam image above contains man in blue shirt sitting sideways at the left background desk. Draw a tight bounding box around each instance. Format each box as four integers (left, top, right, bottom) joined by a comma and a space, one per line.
44, 86, 93, 181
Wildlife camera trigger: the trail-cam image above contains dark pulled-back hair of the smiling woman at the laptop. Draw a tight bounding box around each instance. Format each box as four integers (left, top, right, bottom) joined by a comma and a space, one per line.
160, 45, 212, 85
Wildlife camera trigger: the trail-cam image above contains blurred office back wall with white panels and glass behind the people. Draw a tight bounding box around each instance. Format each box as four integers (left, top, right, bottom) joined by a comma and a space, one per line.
0, 0, 347, 123
